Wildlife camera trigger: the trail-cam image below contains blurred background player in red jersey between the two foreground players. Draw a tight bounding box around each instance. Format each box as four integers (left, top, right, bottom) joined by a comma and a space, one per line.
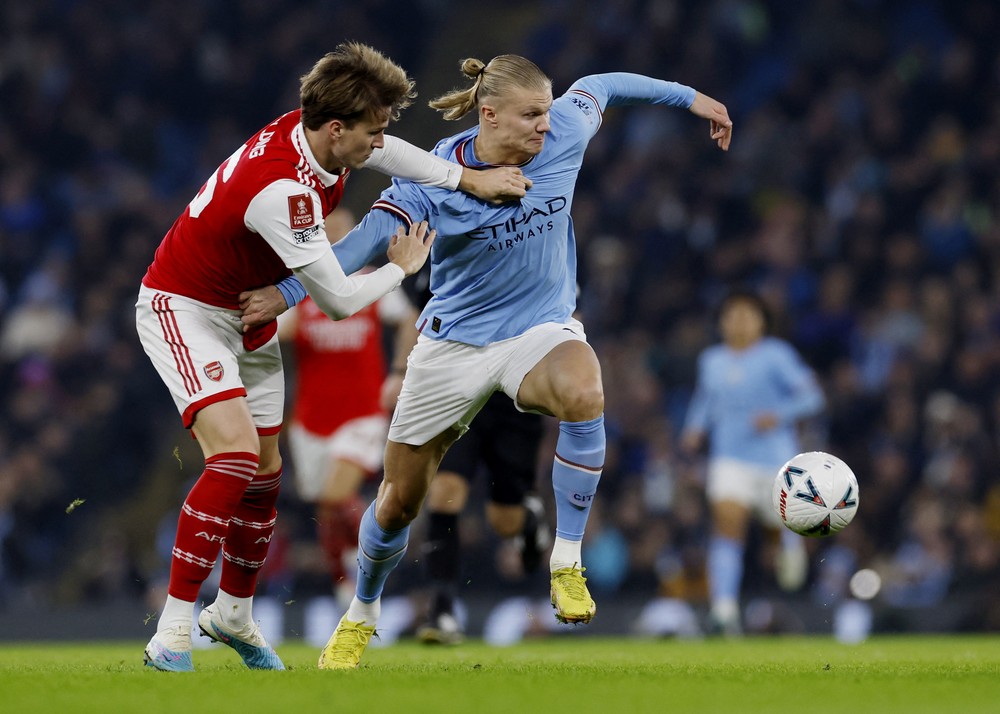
278, 208, 417, 613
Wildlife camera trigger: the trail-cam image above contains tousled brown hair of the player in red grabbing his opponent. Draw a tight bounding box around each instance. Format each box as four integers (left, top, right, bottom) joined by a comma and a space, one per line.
299, 42, 417, 129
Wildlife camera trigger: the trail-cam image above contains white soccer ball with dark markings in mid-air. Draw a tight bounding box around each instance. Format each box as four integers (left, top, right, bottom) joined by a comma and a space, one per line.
772, 451, 859, 538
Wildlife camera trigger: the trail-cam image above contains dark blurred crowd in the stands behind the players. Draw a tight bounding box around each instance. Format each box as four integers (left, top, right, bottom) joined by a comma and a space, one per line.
0, 0, 1000, 630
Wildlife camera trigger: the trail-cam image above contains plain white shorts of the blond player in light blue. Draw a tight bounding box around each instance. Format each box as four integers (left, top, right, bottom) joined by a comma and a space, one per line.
389, 320, 587, 446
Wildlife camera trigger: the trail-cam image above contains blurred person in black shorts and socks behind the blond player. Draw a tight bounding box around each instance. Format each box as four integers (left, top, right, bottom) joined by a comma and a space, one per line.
387, 264, 552, 644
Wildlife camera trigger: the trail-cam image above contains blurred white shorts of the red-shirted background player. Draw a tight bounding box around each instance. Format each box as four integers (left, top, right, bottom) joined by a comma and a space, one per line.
288, 414, 389, 502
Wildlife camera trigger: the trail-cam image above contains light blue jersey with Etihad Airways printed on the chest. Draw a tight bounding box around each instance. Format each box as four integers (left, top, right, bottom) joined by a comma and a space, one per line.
334, 73, 695, 346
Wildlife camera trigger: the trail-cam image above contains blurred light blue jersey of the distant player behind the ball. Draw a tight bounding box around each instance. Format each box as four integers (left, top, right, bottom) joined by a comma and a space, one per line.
684, 337, 825, 473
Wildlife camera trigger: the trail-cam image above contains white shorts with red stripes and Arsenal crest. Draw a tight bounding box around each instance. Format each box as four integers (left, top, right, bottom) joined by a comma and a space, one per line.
135, 285, 285, 428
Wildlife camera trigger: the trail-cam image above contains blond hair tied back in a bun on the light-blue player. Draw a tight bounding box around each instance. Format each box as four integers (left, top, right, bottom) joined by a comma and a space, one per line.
429, 55, 552, 120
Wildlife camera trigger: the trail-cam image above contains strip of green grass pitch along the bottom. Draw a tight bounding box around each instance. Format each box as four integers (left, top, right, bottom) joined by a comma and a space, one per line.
0, 636, 1000, 714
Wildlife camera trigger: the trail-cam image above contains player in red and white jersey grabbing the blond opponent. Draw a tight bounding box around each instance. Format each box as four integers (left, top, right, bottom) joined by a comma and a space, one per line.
136, 43, 530, 671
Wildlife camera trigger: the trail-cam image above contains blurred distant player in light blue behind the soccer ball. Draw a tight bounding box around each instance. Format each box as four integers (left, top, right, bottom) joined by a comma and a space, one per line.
681, 291, 825, 635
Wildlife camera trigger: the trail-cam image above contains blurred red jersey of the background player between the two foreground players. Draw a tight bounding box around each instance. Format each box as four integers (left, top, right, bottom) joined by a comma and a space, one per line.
293, 298, 385, 436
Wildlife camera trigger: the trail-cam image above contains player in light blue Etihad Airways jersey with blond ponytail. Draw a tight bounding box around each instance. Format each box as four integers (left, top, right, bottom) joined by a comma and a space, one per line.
238, 55, 732, 669
